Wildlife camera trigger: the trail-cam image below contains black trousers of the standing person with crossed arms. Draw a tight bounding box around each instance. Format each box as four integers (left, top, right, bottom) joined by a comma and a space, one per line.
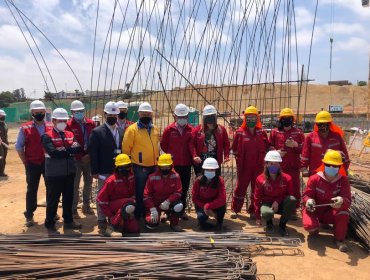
45, 174, 75, 227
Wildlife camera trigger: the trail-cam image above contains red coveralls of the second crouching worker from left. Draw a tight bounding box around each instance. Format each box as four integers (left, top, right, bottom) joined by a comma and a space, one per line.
143, 169, 185, 226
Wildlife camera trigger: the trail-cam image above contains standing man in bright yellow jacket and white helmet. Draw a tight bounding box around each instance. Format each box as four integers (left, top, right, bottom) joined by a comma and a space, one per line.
122, 102, 159, 218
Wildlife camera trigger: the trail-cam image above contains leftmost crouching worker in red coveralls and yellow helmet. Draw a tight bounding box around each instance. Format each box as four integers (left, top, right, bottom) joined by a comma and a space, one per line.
96, 154, 140, 237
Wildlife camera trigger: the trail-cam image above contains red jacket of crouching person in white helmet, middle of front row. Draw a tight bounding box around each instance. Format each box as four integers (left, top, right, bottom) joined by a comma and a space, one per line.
192, 177, 226, 210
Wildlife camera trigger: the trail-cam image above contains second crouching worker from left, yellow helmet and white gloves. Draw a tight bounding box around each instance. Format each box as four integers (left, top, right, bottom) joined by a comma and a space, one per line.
144, 154, 184, 231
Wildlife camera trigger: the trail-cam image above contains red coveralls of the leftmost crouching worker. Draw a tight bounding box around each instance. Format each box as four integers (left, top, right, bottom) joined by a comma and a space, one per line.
96, 173, 140, 233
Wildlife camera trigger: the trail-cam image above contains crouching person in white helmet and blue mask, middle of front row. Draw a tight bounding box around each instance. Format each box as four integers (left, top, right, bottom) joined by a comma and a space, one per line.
192, 158, 226, 230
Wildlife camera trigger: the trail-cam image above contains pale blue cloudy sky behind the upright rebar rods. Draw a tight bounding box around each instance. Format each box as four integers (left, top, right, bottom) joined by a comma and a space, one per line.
0, 0, 370, 98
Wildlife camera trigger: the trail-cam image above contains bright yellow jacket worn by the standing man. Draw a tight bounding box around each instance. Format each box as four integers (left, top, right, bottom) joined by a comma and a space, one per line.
122, 123, 159, 166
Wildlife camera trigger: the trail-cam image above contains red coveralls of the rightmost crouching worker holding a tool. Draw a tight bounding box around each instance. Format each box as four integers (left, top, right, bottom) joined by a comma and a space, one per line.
302, 171, 351, 241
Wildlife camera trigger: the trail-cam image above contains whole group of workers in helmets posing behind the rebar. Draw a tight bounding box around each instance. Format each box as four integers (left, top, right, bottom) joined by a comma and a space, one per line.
16, 100, 351, 250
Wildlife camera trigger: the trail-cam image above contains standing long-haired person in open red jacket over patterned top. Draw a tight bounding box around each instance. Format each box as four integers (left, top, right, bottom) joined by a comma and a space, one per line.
193, 105, 230, 175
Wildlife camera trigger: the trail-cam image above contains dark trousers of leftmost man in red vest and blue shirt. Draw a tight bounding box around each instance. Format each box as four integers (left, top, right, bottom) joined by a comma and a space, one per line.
24, 163, 47, 218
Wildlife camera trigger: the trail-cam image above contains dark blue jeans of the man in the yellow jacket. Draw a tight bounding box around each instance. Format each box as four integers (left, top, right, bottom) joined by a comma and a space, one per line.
133, 164, 156, 219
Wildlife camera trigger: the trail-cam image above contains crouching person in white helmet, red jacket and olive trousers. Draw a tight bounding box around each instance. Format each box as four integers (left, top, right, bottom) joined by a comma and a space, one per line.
254, 151, 296, 236
